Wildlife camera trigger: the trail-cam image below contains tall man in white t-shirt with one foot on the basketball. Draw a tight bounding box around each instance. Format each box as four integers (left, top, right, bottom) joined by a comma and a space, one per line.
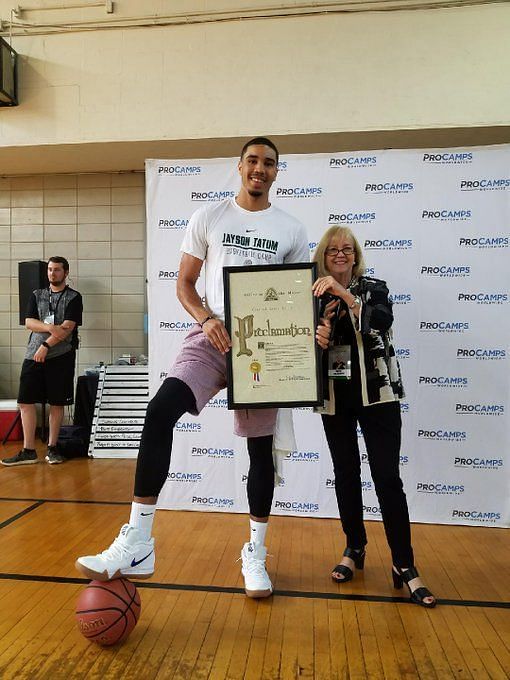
76, 137, 309, 597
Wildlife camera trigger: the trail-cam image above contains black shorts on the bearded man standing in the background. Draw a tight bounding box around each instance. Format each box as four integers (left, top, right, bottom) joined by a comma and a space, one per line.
18, 352, 76, 406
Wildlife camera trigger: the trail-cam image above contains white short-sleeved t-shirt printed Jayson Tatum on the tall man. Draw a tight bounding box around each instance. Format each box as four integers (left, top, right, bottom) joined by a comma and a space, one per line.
181, 198, 310, 319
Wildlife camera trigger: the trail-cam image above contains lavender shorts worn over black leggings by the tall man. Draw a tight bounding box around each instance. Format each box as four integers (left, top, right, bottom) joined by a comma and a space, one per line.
168, 326, 278, 437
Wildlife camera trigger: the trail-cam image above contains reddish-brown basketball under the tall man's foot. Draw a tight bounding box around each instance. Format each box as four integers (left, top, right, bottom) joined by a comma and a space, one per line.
76, 578, 142, 646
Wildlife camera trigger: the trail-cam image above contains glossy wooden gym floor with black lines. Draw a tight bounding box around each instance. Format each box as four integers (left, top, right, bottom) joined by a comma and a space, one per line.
0, 443, 510, 680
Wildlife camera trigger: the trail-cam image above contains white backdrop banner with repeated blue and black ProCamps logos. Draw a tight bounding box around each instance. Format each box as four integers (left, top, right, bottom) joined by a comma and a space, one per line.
146, 145, 510, 526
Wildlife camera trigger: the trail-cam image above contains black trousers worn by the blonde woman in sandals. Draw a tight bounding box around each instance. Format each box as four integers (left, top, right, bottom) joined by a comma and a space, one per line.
322, 401, 414, 567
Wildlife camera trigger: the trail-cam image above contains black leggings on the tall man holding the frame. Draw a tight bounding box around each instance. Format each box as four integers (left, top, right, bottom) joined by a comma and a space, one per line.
135, 378, 274, 517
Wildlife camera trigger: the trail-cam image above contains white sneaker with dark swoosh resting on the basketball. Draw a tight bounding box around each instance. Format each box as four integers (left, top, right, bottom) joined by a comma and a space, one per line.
75, 524, 154, 581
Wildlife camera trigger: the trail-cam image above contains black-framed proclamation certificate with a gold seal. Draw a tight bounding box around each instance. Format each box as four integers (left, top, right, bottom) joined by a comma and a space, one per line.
223, 263, 323, 409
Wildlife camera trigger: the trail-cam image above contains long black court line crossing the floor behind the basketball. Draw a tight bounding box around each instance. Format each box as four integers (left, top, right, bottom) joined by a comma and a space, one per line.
0, 573, 510, 609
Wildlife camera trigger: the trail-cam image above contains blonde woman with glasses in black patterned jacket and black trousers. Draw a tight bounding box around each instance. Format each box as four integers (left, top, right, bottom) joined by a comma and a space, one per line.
314, 227, 436, 607
